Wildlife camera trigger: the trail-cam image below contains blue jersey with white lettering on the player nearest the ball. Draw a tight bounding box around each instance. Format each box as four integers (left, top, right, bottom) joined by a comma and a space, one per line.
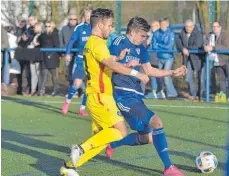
109, 35, 150, 97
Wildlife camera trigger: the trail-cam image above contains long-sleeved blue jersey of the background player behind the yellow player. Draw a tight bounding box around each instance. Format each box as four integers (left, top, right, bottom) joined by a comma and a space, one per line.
66, 23, 91, 61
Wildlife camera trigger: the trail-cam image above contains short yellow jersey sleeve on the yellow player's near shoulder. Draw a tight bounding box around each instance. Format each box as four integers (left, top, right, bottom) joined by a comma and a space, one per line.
93, 43, 110, 62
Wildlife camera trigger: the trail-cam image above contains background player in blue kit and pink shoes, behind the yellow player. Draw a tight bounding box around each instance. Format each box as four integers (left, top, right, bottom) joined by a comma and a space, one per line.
62, 8, 92, 116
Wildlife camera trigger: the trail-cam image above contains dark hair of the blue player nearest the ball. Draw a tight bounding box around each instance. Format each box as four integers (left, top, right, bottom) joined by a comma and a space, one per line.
127, 17, 150, 34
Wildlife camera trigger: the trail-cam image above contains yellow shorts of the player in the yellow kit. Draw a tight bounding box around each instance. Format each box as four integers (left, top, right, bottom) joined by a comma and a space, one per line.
86, 93, 124, 133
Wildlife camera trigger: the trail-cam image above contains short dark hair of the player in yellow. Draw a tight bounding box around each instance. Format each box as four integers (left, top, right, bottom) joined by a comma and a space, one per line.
90, 8, 114, 28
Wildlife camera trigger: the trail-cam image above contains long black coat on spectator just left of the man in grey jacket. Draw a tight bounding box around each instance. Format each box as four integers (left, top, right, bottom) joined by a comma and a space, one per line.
39, 29, 60, 69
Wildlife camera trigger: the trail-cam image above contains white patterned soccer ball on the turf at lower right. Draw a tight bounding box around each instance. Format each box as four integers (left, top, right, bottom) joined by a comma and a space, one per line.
196, 151, 218, 173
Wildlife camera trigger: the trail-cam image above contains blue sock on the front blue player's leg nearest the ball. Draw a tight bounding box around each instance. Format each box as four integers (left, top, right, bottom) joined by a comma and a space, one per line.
153, 128, 172, 169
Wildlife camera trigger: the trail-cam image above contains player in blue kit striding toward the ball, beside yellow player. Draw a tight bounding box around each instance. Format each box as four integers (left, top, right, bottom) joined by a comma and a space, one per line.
106, 17, 186, 176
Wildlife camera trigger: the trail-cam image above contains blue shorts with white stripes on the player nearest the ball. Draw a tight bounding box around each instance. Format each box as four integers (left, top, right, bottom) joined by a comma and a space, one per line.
115, 95, 155, 134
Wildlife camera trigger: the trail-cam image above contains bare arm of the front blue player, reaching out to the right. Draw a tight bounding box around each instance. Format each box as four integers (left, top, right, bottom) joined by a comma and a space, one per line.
142, 62, 187, 77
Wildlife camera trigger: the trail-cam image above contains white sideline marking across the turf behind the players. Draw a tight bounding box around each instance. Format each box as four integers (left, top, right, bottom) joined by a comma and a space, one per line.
1, 99, 229, 110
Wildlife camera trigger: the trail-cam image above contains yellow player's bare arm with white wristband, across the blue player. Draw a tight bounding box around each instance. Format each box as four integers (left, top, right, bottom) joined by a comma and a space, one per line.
102, 56, 149, 84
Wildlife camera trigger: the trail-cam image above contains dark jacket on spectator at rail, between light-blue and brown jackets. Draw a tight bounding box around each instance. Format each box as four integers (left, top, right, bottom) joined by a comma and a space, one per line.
176, 26, 204, 71
